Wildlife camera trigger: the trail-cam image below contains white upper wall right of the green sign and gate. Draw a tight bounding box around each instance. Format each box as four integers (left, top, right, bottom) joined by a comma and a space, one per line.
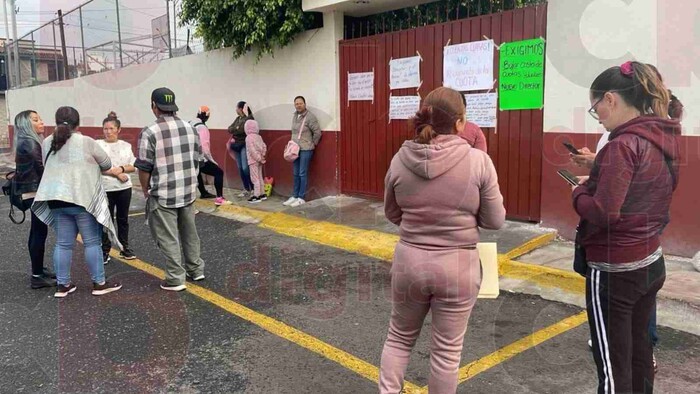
544, 0, 700, 135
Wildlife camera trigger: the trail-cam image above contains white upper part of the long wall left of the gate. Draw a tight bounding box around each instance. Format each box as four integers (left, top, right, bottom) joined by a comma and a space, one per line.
8, 13, 343, 130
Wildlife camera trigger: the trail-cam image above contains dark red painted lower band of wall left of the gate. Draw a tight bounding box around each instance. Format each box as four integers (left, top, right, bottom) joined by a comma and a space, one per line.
30, 126, 340, 200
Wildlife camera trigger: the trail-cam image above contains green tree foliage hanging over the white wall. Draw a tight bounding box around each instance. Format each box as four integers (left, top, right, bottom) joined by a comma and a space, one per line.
180, 0, 313, 60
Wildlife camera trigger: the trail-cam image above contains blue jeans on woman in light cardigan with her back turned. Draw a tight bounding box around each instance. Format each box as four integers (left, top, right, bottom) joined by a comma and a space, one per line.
53, 207, 105, 285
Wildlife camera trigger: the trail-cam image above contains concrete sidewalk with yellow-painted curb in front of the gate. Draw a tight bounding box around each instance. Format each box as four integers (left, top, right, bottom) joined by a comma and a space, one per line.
198, 189, 700, 335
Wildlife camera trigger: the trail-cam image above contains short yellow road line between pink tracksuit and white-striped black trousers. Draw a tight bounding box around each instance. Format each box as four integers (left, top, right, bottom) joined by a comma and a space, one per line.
458, 311, 588, 383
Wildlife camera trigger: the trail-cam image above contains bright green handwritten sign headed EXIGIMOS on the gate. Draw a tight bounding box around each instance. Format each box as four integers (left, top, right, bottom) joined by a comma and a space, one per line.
498, 38, 544, 110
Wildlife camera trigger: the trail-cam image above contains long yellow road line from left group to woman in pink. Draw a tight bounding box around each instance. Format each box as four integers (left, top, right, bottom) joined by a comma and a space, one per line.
104, 249, 421, 393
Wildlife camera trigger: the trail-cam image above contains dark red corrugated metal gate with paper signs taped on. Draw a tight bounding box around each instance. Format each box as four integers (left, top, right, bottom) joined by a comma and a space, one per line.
340, 4, 547, 221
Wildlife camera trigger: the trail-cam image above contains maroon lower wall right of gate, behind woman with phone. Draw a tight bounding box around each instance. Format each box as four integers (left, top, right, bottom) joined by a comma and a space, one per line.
542, 133, 700, 257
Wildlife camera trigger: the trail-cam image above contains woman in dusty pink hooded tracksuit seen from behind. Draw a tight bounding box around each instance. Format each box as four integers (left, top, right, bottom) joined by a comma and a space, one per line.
379, 88, 505, 394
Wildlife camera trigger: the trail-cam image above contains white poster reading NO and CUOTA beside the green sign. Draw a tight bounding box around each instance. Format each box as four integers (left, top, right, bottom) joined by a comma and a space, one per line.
442, 40, 494, 92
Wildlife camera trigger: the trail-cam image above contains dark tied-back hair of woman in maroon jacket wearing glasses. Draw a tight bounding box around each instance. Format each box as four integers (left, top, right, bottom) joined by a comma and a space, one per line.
591, 62, 680, 119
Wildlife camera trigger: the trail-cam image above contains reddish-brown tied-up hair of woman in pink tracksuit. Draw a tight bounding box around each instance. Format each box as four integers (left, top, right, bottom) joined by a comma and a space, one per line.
409, 87, 466, 144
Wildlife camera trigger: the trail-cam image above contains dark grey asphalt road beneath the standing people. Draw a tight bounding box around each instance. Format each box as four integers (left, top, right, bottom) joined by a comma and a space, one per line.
0, 199, 700, 393
